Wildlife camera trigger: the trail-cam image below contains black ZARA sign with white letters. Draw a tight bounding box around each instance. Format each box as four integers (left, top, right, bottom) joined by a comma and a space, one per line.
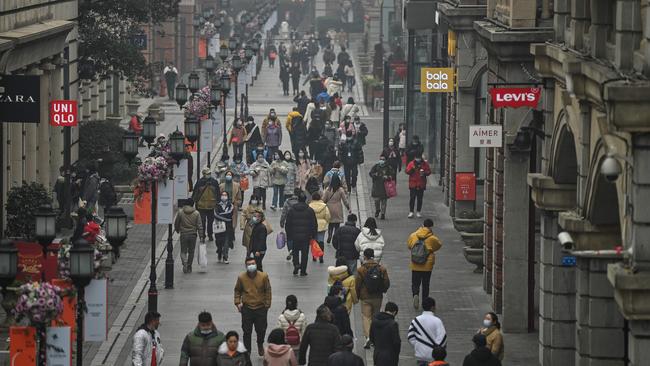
0, 75, 41, 123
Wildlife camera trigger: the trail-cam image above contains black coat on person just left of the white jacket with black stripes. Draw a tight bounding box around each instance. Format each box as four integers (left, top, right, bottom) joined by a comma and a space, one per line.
370, 312, 402, 366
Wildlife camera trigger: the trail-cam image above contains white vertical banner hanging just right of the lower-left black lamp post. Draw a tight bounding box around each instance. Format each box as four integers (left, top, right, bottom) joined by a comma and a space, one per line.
84, 279, 108, 342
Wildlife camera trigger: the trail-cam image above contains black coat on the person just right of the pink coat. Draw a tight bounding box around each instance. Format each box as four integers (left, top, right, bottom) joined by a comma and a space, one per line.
298, 320, 341, 366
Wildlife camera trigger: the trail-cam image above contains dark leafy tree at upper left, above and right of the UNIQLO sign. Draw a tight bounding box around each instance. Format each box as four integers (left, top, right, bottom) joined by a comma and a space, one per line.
78, 0, 180, 93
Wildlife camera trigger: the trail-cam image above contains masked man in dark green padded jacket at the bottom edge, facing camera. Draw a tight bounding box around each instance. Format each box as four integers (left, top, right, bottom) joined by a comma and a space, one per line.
179, 311, 225, 366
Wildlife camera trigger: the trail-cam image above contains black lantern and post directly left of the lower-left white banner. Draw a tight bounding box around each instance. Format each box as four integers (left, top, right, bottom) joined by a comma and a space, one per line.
70, 239, 95, 366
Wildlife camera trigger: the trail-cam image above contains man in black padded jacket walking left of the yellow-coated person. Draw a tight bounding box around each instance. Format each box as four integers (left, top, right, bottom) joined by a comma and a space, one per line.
285, 192, 318, 276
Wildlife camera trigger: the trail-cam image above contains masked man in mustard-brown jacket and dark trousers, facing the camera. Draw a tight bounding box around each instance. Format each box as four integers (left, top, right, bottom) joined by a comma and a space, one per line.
235, 256, 272, 356
